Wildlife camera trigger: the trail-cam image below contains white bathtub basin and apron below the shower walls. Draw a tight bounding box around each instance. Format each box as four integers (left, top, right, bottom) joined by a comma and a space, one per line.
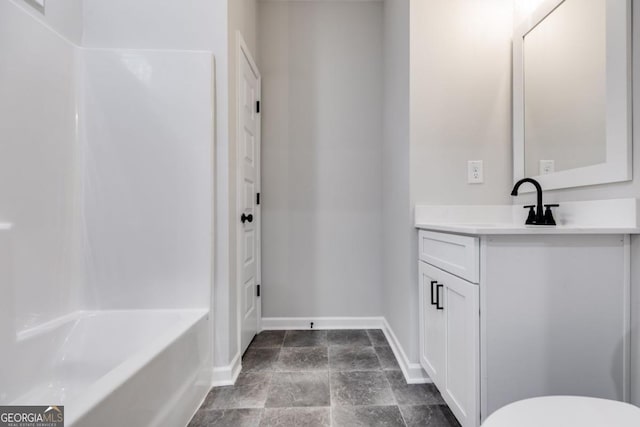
0, 310, 211, 427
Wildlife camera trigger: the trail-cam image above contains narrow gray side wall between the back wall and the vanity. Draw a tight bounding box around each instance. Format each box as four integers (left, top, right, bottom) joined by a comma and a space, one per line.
382, 0, 418, 362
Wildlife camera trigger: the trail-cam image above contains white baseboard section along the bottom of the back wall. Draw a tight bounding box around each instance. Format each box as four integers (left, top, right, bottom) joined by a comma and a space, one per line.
262, 317, 384, 331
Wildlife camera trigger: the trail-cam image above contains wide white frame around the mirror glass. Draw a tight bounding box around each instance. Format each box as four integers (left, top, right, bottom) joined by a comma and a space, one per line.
513, 0, 633, 191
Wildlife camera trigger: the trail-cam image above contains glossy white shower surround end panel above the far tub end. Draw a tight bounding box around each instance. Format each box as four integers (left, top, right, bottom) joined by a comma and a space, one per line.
79, 49, 213, 309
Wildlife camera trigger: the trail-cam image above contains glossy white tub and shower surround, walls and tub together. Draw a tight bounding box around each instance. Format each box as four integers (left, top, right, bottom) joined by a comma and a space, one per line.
0, 2, 214, 426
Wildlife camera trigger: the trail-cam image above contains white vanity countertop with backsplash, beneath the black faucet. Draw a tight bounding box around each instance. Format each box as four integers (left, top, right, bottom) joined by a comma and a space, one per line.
415, 199, 640, 235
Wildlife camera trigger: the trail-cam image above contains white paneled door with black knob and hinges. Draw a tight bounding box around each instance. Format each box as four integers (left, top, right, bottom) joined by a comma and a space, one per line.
237, 34, 260, 353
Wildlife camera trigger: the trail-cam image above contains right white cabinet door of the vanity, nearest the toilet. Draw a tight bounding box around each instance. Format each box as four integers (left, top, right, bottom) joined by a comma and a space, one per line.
440, 273, 480, 427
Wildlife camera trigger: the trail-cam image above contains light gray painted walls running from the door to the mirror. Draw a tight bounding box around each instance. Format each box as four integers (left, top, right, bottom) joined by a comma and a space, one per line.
258, 0, 513, 368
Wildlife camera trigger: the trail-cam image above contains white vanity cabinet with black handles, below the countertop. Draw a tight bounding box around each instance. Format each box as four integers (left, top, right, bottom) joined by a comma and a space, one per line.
419, 230, 630, 427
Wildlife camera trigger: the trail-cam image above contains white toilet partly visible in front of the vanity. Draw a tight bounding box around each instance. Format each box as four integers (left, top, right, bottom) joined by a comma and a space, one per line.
482, 396, 640, 427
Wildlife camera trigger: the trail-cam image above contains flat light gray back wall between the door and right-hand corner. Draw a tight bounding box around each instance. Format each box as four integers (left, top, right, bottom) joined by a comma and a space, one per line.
258, 2, 384, 317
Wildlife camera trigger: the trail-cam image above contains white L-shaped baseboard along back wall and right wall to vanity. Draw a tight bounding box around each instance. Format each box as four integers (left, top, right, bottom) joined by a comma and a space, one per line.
262, 317, 432, 384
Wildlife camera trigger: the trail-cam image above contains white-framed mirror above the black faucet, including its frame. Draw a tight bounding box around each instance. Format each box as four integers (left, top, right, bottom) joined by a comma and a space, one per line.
513, 0, 632, 189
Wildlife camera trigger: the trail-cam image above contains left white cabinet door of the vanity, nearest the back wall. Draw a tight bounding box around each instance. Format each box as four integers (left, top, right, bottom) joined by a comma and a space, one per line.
419, 262, 445, 385
